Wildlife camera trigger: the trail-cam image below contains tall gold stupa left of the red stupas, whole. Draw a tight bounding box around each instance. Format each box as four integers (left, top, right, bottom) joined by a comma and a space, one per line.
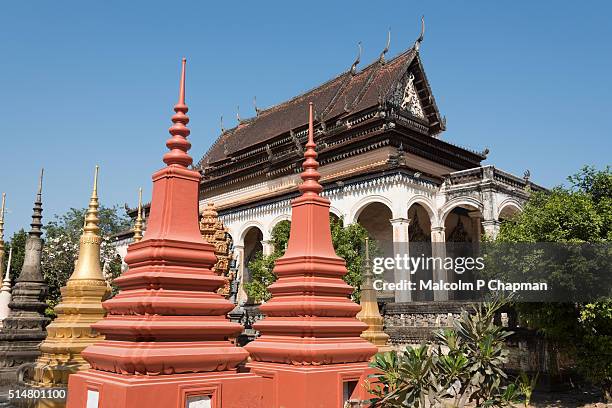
31, 166, 110, 407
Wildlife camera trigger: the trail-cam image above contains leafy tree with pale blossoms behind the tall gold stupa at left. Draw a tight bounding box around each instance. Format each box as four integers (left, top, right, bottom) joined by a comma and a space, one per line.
42, 206, 130, 317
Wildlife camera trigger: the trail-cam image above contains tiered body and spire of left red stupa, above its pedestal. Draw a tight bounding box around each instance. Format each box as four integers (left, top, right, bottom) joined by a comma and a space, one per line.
77, 59, 247, 382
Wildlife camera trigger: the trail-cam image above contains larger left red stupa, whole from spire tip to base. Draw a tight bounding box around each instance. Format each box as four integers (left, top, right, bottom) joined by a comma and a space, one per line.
68, 59, 258, 408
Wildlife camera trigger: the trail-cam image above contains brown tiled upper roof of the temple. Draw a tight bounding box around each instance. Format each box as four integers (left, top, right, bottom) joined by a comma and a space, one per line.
198, 47, 444, 168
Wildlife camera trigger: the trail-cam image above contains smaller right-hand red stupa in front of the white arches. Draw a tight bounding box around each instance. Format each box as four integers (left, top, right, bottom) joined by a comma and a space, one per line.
245, 104, 377, 408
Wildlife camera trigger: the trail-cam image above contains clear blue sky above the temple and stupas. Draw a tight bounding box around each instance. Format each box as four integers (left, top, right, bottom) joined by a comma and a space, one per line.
0, 0, 612, 235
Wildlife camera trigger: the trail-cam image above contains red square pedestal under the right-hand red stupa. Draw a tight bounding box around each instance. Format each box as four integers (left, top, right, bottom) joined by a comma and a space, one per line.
245, 362, 371, 408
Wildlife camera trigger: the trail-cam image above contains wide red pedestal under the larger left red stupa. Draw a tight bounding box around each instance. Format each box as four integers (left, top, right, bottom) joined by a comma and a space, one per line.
67, 370, 262, 408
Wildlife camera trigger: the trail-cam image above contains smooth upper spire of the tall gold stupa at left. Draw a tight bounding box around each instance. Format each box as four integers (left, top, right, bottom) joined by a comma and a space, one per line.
68, 166, 105, 284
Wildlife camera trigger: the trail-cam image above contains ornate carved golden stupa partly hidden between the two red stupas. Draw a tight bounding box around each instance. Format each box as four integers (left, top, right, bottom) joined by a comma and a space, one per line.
200, 203, 234, 296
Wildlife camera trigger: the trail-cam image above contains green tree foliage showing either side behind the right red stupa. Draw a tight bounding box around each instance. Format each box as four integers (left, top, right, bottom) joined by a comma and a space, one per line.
244, 216, 377, 302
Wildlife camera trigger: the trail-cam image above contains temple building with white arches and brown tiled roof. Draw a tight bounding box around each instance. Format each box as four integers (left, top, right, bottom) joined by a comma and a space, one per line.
197, 41, 541, 301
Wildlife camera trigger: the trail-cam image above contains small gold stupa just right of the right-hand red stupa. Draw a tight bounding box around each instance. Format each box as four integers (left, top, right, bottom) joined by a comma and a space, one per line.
357, 238, 391, 352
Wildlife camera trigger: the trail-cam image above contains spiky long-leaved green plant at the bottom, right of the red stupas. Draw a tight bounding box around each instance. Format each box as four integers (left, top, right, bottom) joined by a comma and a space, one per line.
369, 300, 519, 408
